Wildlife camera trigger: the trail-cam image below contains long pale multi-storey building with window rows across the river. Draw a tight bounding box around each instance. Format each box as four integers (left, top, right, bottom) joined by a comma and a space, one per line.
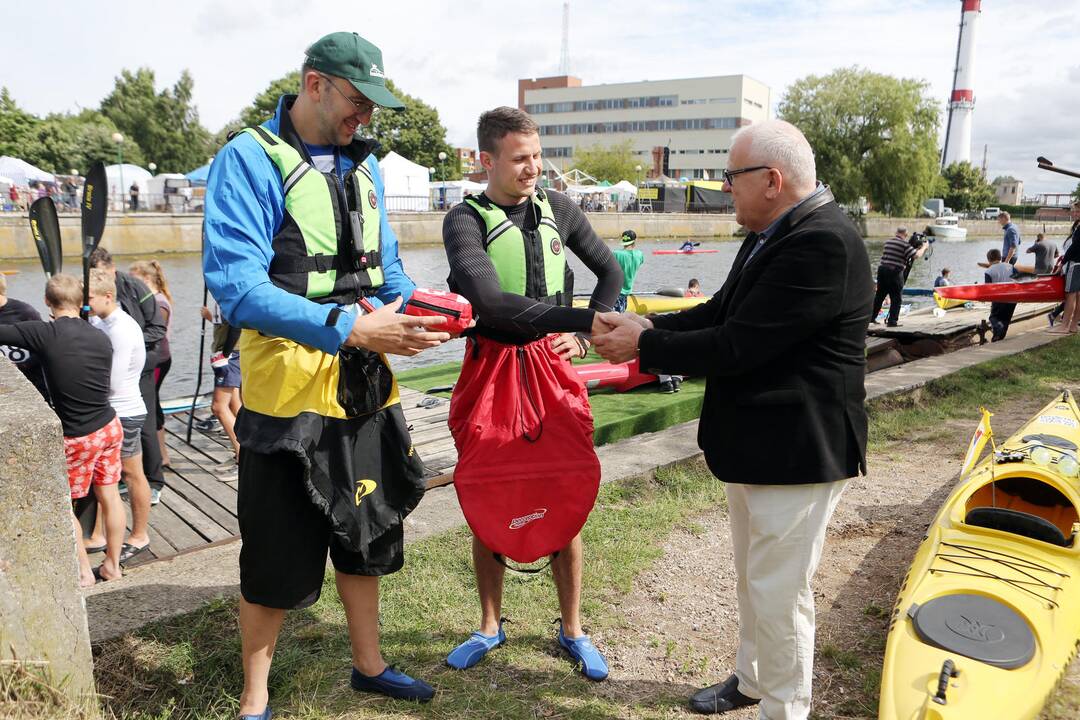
518, 74, 772, 180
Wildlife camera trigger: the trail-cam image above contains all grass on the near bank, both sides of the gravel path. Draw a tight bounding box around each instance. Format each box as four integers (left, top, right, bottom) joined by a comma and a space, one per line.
71, 339, 1080, 720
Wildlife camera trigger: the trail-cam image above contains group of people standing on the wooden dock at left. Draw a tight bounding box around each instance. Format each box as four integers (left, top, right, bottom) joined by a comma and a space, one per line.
0, 247, 247, 586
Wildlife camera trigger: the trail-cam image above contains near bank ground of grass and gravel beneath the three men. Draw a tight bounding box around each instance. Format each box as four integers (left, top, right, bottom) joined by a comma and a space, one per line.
12, 338, 1080, 720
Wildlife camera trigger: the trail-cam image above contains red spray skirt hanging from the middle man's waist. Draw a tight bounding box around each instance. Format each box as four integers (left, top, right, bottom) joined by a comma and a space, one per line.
449, 337, 600, 562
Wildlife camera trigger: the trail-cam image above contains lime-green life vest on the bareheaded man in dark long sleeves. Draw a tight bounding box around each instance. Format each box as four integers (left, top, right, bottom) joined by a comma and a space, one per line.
464, 188, 570, 304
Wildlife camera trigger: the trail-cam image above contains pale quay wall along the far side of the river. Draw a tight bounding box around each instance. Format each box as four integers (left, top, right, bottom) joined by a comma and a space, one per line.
0, 213, 1069, 263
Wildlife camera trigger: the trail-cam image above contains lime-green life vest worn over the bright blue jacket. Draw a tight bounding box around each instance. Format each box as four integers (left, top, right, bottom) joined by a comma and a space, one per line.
242, 126, 382, 304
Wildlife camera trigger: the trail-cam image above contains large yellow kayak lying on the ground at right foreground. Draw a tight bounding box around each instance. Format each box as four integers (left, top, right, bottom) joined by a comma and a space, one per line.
878, 391, 1080, 720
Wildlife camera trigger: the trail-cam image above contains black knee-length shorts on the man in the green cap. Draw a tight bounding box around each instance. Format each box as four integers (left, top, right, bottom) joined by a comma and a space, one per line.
237, 447, 405, 609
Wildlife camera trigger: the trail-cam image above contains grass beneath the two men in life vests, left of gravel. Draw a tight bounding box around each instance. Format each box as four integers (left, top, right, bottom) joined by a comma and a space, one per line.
95, 462, 724, 720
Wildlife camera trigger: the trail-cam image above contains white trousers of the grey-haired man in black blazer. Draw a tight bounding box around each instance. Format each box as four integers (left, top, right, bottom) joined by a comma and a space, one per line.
727, 480, 848, 720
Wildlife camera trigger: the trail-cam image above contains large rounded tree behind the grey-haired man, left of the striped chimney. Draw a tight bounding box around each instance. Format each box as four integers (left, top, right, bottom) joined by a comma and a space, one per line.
778, 68, 941, 215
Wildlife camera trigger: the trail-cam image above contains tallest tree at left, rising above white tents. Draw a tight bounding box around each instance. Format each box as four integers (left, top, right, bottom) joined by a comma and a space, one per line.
102, 68, 212, 173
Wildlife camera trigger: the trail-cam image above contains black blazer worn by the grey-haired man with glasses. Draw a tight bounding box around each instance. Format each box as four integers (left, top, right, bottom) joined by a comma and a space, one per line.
638, 190, 874, 485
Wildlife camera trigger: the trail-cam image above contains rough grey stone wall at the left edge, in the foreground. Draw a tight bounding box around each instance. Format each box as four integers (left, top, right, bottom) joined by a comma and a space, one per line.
0, 357, 94, 704
